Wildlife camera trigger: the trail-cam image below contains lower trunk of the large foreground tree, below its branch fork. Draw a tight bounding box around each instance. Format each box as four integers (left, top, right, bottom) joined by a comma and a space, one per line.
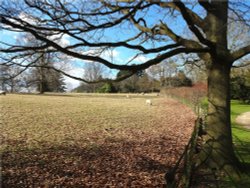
202, 61, 239, 171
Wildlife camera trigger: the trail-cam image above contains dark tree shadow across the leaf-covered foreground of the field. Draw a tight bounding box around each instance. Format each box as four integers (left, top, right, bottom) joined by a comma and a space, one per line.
2, 137, 174, 188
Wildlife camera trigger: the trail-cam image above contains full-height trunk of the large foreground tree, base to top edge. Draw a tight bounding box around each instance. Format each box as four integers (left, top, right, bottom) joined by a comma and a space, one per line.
196, 1, 240, 173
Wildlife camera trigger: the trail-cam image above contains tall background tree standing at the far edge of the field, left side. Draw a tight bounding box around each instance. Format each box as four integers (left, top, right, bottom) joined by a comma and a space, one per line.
6, 33, 66, 93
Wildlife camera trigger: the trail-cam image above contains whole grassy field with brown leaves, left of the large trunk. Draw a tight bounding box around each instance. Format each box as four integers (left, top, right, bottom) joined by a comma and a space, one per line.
0, 94, 195, 187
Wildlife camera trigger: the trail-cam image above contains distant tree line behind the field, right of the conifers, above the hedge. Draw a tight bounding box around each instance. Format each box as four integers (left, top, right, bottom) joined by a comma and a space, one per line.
73, 62, 192, 93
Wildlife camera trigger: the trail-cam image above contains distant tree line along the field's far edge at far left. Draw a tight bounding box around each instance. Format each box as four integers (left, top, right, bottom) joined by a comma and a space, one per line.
0, 54, 66, 93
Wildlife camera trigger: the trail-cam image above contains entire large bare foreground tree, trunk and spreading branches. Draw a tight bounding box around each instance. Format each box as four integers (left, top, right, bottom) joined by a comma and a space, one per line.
0, 0, 250, 176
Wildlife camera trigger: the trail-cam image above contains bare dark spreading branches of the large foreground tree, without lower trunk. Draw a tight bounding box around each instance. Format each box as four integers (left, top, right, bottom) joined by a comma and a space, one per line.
0, 0, 247, 82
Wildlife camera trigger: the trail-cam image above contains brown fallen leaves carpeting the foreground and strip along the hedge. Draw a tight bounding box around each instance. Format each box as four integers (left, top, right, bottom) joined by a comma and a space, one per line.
2, 94, 195, 188
